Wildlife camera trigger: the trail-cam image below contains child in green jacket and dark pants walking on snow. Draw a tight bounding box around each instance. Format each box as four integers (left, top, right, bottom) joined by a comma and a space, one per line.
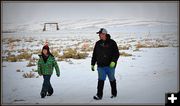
38, 45, 60, 98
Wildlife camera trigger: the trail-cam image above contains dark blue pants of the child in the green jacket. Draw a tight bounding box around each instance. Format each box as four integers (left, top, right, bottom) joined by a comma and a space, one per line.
41, 75, 54, 95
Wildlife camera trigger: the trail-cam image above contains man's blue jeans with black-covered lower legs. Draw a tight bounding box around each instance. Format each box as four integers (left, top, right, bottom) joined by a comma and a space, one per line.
97, 67, 117, 98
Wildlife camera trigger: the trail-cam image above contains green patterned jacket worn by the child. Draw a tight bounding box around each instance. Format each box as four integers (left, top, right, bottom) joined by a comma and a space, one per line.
38, 55, 60, 75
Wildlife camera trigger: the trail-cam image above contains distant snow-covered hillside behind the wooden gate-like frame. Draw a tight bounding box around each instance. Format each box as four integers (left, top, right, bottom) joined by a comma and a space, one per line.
2, 18, 178, 33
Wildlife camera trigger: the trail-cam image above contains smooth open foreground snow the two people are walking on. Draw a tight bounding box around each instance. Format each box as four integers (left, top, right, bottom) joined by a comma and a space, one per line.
2, 48, 179, 104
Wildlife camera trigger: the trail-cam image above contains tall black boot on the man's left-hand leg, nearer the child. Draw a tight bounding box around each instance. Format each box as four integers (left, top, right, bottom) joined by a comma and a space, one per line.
94, 80, 104, 100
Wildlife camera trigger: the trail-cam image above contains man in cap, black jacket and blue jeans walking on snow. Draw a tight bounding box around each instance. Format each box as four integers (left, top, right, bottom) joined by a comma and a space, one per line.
91, 28, 120, 100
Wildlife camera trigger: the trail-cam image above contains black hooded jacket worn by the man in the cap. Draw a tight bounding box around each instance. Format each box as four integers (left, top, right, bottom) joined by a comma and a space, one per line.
91, 34, 120, 67
